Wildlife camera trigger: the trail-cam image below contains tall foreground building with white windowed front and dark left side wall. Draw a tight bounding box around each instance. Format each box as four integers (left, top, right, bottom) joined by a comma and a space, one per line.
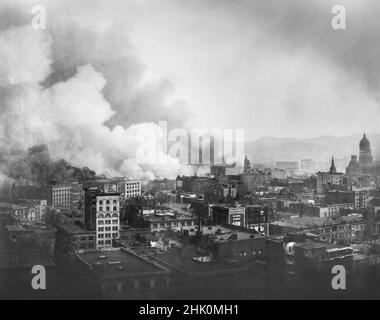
85, 188, 120, 250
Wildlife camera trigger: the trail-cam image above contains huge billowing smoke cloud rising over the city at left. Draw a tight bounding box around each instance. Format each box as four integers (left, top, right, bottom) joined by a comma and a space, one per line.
0, 0, 196, 183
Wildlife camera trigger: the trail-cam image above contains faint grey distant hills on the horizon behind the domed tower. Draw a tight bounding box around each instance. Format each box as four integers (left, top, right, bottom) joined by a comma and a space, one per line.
245, 134, 380, 163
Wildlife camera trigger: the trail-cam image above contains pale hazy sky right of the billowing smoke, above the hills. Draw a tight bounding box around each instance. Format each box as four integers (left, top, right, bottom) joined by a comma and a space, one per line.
120, 0, 380, 139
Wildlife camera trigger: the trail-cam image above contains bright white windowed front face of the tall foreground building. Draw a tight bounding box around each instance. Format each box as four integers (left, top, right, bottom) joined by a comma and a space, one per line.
96, 194, 120, 250
